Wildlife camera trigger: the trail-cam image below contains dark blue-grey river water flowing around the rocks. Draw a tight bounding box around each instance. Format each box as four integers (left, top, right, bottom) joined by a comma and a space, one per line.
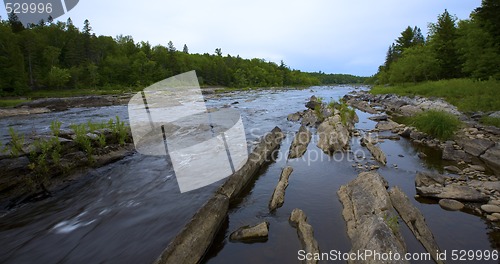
0, 86, 500, 263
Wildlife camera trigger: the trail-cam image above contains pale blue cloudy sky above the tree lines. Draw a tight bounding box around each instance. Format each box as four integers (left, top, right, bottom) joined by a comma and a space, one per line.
0, 0, 481, 76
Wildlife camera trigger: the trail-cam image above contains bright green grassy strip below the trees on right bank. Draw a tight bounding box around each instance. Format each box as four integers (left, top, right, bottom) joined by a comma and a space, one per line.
370, 79, 500, 112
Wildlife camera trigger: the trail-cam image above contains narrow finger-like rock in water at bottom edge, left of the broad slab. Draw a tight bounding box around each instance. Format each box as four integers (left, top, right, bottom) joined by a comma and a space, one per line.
289, 208, 320, 264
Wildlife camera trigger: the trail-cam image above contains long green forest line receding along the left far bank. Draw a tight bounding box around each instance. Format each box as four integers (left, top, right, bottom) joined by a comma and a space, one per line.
0, 14, 365, 96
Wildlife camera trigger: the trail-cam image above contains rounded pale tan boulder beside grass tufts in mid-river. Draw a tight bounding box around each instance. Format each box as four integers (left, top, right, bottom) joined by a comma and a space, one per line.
317, 115, 350, 154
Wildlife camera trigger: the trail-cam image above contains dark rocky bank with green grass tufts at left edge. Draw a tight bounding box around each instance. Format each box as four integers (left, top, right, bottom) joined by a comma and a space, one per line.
0, 117, 135, 210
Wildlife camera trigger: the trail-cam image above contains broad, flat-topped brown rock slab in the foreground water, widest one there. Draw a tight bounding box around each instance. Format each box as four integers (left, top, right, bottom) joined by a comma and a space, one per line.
337, 172, 409, 263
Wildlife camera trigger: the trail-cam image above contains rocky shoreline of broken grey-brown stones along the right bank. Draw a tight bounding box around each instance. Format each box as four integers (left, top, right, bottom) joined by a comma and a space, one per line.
344, 91, 500, 222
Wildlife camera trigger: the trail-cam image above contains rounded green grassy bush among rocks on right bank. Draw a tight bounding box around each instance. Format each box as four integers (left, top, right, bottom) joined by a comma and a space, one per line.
411, 110, 461, 140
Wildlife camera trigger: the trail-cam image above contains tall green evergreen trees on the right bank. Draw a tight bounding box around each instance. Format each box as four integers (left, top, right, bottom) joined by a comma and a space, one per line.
369, 0, 500, 84
